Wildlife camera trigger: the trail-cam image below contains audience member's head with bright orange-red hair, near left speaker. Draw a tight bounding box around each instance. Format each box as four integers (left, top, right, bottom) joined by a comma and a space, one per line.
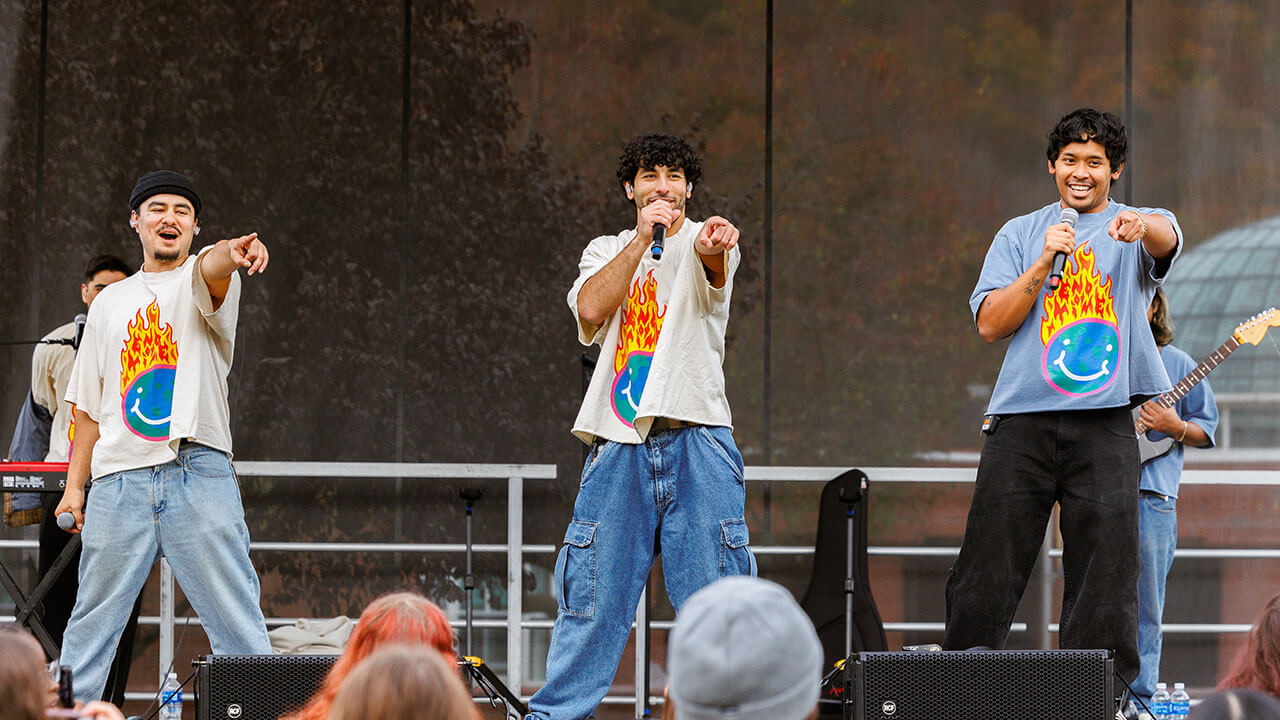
289, 592, 454, 720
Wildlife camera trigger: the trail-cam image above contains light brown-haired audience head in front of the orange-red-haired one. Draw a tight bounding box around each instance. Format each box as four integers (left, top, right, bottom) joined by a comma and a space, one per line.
329, 644, 480, 720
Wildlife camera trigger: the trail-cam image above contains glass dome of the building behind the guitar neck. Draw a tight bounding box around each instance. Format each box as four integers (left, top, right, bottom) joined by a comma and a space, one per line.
1165, 217, 1280, 446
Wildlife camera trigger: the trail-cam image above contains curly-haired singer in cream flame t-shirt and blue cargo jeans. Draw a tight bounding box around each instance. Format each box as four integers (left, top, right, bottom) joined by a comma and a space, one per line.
529, 135, 755, 720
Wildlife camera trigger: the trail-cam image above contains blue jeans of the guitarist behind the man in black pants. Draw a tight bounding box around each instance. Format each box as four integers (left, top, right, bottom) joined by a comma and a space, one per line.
1133, 492, 1178, 706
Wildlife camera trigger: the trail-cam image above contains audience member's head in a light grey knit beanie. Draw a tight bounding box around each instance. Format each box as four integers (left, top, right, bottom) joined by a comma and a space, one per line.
667, 575, 822, 720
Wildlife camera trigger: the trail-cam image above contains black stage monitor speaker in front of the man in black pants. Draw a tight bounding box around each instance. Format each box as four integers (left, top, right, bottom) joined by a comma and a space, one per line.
854, 650, 1115, 720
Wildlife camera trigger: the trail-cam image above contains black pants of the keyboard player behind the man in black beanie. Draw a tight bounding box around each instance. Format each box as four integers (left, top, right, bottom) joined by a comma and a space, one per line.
38, 492, 142, 707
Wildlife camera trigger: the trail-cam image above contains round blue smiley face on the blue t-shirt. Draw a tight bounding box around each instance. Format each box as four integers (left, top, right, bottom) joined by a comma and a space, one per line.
1042, 319, 1120, 396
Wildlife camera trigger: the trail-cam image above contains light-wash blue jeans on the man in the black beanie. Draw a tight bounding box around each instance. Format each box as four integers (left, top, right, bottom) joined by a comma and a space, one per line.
61, 443, 271, 701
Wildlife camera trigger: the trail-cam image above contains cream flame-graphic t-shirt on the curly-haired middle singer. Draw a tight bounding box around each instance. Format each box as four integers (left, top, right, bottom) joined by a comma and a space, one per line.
568, 219, 741, 443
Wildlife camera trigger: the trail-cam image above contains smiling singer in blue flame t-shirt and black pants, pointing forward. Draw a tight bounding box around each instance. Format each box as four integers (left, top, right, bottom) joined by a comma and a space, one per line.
943, 108, 1181, 680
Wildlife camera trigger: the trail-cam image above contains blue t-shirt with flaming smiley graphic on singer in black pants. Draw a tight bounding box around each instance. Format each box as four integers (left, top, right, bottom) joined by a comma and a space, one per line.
969, 200, 1183, 415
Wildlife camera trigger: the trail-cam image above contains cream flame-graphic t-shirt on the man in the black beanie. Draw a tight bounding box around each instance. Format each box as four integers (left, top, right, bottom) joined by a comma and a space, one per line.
67, 247, 239, 479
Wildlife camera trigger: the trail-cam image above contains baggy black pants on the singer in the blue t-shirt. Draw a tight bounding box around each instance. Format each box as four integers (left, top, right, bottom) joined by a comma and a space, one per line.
942, 407, 1140, 680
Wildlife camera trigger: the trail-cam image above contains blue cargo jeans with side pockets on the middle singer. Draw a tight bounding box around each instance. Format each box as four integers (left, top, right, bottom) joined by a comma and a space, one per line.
527, 425, 755, 720
